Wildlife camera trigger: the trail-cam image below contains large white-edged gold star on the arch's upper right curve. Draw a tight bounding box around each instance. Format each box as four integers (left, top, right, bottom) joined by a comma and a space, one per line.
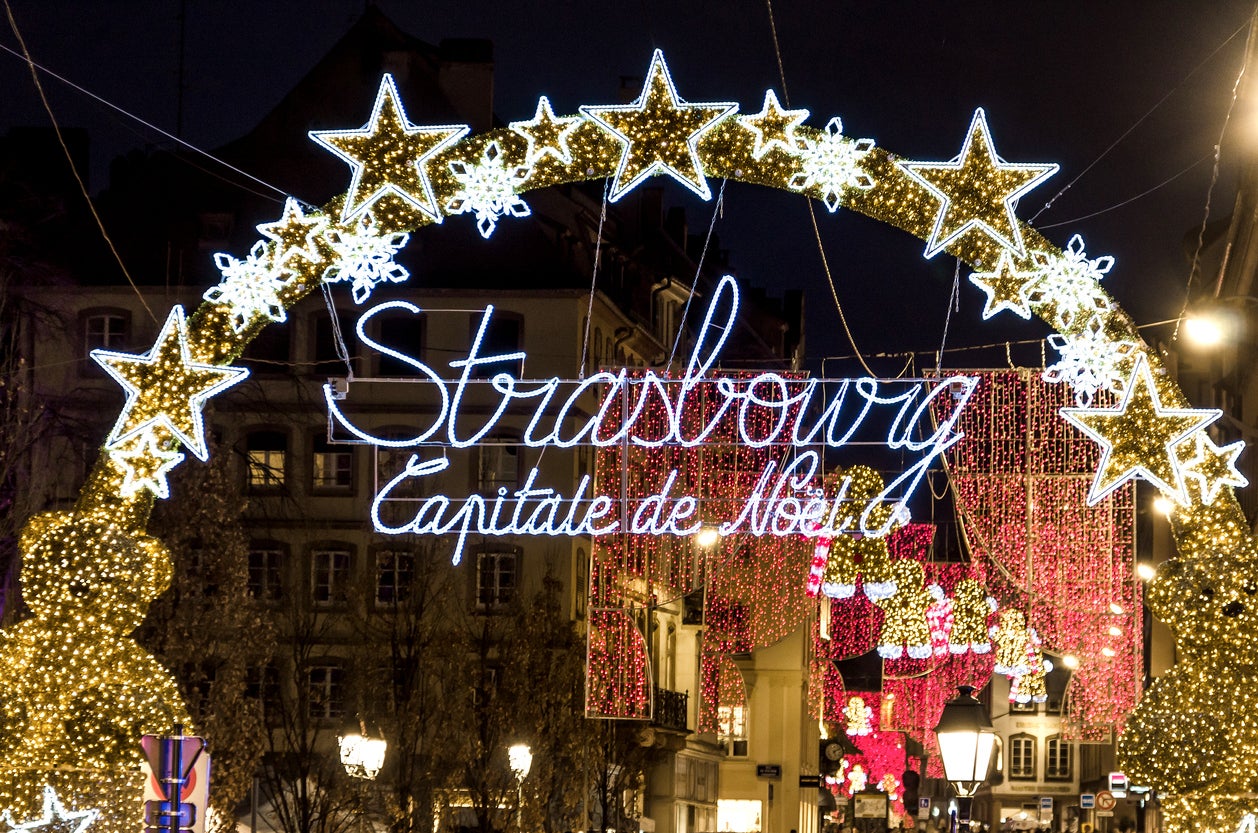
897, 107, 1057, 258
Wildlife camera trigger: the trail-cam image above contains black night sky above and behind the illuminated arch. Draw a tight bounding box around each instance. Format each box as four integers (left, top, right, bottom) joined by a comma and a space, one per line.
0, 0, 1253, 372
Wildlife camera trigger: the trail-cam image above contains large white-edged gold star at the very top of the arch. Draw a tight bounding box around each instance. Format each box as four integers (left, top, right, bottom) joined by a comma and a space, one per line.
581, 49, 738, 203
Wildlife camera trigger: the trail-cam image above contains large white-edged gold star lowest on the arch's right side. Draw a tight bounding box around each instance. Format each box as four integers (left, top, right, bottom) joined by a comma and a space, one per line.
1060, 355, 1223, 506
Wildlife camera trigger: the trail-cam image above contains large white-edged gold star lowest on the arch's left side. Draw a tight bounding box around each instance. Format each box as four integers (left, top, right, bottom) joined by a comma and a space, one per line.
92, 306, 249, 459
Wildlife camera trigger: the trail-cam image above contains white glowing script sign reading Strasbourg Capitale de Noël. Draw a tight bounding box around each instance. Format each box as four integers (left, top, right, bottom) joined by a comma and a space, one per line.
323, 277, 977, 564
